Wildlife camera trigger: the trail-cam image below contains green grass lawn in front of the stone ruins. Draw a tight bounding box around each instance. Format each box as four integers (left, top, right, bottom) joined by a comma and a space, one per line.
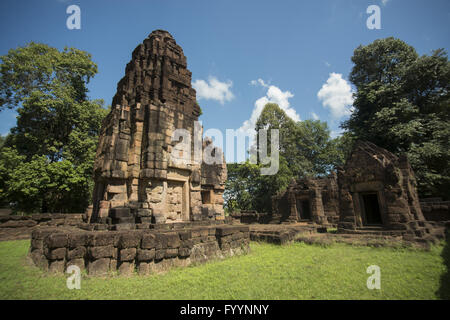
0, 240, 450, 299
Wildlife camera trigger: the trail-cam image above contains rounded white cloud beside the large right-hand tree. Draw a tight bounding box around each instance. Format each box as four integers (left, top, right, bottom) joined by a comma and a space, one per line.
317, 72, 353, 119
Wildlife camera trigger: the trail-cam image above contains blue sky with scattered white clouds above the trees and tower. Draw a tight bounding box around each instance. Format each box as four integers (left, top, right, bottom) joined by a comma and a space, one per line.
0, 0, 450, 160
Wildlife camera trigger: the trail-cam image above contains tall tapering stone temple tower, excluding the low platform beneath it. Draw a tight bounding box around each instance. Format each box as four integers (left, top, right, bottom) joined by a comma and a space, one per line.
91, 30, 226, 223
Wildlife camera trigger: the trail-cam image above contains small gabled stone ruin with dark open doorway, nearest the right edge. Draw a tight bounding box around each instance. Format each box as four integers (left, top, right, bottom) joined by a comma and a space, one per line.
338, 141, 425, 233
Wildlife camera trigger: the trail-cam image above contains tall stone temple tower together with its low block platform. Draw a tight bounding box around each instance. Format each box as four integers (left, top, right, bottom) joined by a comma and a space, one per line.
29, 30, 250, 275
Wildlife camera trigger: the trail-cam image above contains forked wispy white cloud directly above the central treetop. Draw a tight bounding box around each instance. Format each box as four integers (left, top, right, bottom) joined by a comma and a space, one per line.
238, 79, 300, 139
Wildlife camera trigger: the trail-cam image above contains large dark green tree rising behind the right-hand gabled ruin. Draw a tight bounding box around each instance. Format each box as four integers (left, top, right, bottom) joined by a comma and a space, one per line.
343, 38, 450, 198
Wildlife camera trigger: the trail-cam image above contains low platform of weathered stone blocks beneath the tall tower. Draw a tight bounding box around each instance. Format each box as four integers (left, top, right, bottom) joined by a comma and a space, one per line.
29, 225, 250, 275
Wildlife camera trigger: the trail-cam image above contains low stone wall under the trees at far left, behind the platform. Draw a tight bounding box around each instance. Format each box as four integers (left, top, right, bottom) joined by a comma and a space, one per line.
0, 213, 84, 240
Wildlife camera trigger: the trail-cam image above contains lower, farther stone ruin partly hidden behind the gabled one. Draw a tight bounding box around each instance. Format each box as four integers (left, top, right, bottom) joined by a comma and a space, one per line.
272, 173, 339, 224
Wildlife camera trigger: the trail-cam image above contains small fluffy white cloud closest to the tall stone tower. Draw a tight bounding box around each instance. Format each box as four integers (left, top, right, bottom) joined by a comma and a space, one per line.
192, 77, 234, 104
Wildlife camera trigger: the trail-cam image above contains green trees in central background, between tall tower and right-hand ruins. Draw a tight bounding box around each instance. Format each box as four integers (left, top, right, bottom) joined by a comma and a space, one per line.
224, 103, 348, 212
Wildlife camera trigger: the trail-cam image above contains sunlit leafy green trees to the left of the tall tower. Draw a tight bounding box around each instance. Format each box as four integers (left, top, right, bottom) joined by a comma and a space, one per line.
0, 43, 107, 212
